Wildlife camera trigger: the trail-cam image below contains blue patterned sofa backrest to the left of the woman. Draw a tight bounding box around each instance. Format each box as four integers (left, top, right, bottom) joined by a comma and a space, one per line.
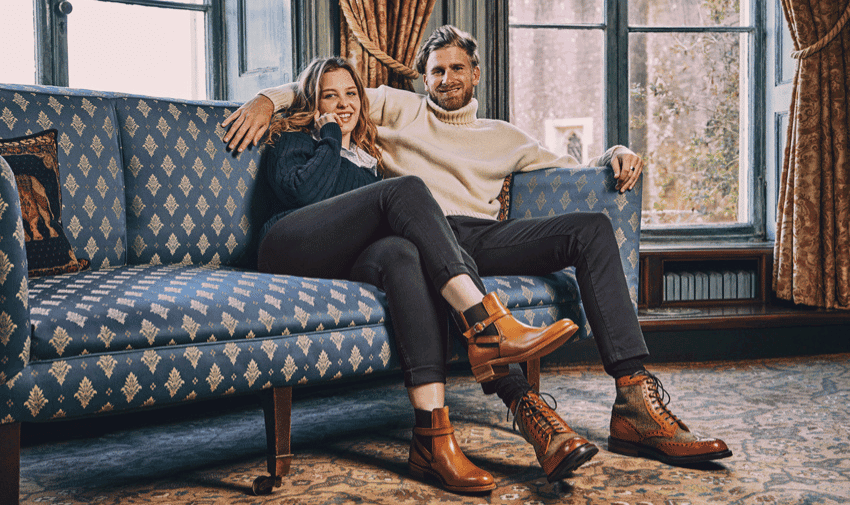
0, 84, 268, 269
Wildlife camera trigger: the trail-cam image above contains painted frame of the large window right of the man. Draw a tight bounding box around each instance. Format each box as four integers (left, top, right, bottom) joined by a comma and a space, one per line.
504, 0, 767, 243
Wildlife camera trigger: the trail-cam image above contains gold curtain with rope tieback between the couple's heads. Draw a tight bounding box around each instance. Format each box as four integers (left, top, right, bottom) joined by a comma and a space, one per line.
339, 0, 436, 90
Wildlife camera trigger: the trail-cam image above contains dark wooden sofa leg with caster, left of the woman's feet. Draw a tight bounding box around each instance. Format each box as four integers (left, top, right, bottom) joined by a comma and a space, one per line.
251, 387, 292, 495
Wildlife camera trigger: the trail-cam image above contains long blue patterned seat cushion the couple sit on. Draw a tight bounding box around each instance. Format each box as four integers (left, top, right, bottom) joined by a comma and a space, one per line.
30, 265, 578, 360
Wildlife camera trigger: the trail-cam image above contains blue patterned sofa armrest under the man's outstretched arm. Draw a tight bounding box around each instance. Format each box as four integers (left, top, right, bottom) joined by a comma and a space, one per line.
508, 167, 643, 310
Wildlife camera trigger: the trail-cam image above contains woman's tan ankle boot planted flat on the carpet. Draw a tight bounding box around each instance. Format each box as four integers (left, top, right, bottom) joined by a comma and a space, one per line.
407, 407, 496, 493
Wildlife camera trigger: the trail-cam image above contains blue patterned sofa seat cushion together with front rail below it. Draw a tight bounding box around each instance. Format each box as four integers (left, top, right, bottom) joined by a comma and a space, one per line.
0, 265, 577, 422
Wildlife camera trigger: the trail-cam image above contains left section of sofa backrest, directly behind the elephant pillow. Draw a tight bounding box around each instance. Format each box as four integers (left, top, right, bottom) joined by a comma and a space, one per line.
0, 84, 127, 268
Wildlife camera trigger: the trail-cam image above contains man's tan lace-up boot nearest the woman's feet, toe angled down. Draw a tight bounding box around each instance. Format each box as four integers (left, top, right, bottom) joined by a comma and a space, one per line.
511, 391, 599, 482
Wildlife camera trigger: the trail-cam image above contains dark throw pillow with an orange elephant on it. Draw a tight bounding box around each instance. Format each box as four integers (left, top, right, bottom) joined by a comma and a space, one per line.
0, 129, 89, 277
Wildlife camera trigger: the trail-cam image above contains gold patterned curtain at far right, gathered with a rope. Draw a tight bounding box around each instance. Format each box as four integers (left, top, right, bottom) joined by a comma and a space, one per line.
773, 0, 850, 309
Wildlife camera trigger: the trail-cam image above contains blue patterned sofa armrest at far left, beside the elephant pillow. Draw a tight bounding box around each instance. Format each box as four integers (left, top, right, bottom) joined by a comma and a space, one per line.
0, 157, 30, 384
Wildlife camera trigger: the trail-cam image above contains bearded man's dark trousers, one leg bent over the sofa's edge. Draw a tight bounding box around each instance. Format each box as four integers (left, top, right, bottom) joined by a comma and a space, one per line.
448, 212, 649, 367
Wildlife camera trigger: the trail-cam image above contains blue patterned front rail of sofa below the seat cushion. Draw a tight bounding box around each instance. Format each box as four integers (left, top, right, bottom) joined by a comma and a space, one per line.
0, 325, 398, 422
